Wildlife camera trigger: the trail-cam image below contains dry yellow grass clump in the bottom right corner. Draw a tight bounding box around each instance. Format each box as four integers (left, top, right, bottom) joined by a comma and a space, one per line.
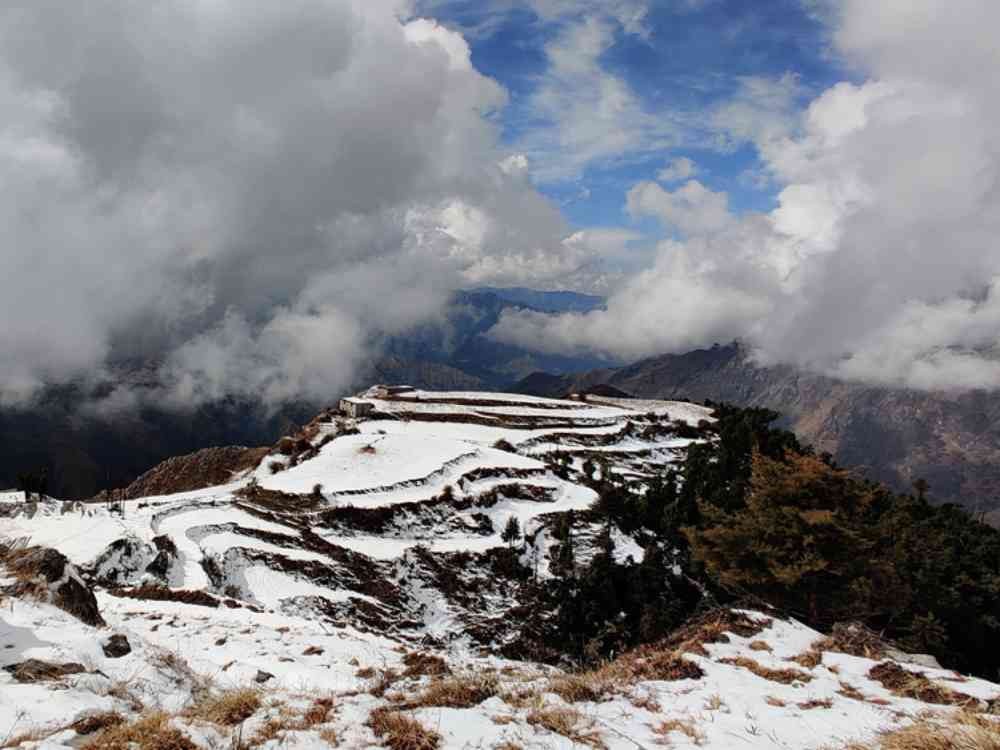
843, 711, 1000, 750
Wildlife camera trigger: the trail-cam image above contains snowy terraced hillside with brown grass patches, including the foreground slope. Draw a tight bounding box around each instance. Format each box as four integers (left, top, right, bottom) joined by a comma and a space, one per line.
0, 388, 1000, 750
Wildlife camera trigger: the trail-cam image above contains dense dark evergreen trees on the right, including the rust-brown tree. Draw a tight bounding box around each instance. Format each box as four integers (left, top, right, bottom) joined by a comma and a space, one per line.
684, 407, 1000, 679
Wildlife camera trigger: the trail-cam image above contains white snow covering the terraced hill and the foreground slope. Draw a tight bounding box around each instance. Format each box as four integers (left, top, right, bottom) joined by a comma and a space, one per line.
0, 390, 1000, 750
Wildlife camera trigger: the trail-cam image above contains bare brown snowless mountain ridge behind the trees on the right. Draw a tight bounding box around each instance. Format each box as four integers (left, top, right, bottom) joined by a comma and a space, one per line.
514, 345, 1000, 511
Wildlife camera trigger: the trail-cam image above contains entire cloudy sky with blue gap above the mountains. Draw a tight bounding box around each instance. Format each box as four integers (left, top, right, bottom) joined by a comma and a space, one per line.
0, 0, 1000, 408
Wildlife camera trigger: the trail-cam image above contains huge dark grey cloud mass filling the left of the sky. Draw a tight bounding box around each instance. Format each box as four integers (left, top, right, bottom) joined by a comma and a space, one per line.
0, 0, 568, 403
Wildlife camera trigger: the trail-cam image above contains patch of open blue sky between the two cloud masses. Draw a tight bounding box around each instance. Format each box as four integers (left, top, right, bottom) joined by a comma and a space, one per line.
421, 0, 850, 234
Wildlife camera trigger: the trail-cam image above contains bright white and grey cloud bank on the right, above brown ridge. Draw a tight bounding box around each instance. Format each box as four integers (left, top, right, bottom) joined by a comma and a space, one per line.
494, 0, 1000, 396
